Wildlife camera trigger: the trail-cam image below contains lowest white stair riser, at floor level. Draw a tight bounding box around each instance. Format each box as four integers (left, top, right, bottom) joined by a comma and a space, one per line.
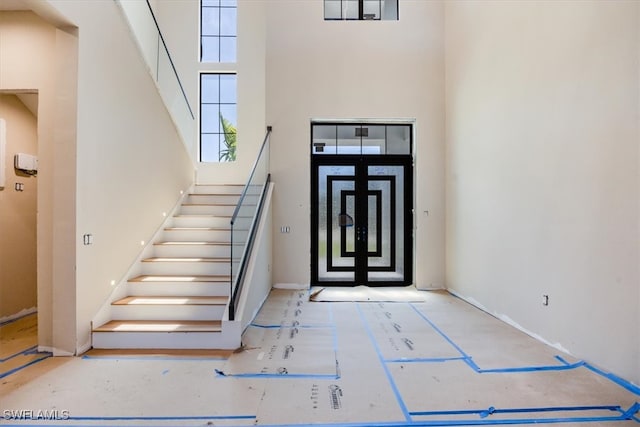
93, 332, 240, 350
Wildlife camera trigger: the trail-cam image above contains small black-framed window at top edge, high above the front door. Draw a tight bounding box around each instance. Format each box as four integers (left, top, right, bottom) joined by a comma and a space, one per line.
324, 0, 398, 21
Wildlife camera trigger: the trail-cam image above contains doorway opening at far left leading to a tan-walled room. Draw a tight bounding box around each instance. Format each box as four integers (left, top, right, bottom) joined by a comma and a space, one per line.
0, 90, 40, 362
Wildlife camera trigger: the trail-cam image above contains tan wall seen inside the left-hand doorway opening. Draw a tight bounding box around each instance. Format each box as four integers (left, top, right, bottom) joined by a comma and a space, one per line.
0, 93, 38, 320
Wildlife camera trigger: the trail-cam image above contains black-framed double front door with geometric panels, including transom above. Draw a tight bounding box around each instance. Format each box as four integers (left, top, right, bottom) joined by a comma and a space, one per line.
311, 122, 413, 286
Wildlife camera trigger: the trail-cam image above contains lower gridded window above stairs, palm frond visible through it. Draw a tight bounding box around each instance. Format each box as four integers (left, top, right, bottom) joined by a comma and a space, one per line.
200, 73, 238, 162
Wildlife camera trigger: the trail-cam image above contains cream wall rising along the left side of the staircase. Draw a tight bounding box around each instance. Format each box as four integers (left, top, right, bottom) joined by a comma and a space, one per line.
45, 0, 194, 351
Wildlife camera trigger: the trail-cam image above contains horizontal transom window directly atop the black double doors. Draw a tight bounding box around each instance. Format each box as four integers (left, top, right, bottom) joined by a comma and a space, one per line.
311, 123, 412, 155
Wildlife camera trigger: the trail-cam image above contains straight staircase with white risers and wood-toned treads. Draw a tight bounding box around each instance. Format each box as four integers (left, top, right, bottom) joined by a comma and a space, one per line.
93, 185, 243, 349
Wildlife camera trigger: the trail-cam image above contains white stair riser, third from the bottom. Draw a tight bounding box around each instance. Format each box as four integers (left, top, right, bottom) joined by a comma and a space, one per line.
127, 282, 230, 297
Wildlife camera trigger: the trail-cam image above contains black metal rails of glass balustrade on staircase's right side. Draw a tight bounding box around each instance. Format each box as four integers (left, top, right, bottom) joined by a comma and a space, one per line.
229, 126, 272, 320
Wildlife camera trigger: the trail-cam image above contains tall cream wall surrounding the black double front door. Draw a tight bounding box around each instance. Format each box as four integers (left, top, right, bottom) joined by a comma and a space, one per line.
266, 0, 444, 287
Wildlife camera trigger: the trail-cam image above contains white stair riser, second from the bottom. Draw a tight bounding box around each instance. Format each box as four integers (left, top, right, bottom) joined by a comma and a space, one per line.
111, 305, 226, 321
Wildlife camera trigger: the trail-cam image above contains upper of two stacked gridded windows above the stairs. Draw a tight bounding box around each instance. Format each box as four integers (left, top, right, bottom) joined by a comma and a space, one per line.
200, 0, 238, 62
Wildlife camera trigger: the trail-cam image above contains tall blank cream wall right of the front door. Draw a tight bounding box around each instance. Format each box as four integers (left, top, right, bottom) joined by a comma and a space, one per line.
445, 1, 640, 383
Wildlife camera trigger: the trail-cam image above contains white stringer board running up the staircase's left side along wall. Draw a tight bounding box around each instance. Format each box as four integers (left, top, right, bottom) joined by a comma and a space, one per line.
89, 184, 194, 336
